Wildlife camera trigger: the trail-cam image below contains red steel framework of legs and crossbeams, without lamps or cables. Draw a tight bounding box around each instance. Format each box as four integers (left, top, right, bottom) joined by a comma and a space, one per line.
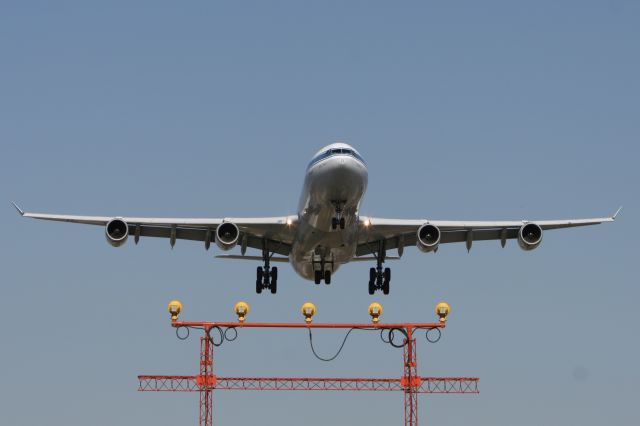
138, 321, 479, 426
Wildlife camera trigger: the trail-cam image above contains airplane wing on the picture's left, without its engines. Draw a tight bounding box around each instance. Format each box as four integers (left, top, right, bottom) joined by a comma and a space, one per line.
12, 203, 297, 256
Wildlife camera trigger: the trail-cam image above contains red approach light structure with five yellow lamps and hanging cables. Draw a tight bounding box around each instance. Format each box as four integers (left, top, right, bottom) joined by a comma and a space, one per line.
138, 300, 480, 426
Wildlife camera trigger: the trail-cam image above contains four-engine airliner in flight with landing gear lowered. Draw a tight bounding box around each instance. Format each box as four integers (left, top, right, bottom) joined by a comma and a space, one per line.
12, 143, 621, 295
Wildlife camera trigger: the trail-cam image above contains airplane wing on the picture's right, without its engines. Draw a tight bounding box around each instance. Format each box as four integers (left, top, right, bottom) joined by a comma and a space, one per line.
356, 208, 621, 256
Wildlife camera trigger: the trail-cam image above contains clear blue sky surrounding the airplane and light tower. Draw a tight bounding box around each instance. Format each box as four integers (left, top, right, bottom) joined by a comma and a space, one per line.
0, 0, 640, 426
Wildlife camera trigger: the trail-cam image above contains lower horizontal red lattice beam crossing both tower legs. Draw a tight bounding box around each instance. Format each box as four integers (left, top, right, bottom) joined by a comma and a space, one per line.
138, 376, 480, 394
